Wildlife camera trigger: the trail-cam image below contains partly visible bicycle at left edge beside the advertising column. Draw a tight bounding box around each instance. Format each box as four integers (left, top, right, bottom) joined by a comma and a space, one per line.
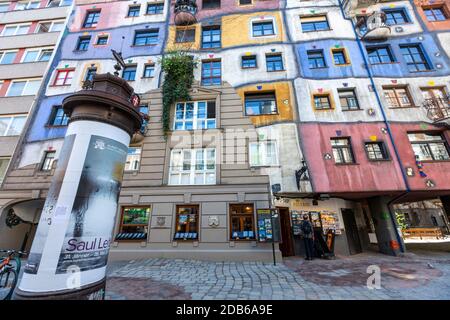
0, 250, 26, 300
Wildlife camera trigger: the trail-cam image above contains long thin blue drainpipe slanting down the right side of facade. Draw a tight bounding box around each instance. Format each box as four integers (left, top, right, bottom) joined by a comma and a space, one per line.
338, 0, 411, 252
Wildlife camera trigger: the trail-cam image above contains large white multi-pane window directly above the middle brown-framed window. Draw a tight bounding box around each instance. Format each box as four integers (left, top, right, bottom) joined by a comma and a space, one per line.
169, 148, 216, 185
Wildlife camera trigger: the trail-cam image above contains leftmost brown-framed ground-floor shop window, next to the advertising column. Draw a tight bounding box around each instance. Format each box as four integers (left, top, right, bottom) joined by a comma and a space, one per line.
115, 207, 151, 241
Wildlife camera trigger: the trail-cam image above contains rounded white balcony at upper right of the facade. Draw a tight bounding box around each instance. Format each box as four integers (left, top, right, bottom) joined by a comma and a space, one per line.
355, 11, 391, 41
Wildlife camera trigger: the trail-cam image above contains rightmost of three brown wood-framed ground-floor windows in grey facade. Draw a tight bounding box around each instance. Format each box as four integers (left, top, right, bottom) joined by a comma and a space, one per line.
230, 203, 256, 240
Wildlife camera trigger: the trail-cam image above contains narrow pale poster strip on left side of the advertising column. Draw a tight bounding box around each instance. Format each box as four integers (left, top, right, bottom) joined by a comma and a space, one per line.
24, 134, 76, 274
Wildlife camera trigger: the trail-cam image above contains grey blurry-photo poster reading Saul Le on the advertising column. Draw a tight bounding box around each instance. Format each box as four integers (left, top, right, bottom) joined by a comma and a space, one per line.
56, 135, 128, 274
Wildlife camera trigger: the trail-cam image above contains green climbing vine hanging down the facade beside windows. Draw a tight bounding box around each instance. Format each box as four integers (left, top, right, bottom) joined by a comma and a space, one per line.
160, 51, 197, 137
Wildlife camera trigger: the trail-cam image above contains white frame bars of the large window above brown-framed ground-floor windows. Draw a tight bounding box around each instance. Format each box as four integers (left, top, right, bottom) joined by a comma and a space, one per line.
168, 148, 217, 185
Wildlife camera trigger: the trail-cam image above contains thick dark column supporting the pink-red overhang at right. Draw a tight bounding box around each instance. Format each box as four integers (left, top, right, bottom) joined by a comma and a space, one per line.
367, 196, 405, 256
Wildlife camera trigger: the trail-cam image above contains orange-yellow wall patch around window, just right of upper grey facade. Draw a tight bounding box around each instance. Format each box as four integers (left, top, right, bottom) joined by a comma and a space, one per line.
237, 82, 295, 127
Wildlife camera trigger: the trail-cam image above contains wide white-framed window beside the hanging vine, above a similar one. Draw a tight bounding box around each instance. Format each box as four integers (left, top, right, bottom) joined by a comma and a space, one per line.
174, 101, 216, 130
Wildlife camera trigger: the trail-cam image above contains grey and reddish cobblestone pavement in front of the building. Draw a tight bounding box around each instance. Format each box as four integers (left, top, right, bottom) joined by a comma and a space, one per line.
106, 252, 450, 300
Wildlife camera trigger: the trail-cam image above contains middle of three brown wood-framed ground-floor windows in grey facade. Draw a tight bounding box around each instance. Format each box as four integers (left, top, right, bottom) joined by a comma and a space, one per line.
174, 205, 199, 240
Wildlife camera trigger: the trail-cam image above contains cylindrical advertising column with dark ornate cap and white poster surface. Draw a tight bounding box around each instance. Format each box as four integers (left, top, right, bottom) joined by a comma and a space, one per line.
14, 73, 142, 299
